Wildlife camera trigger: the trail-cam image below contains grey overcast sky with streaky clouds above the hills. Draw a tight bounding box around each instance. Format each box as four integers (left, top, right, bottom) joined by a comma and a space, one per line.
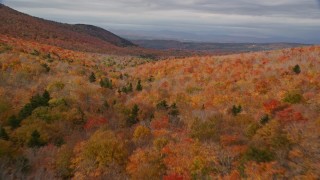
0, 0, 320, 44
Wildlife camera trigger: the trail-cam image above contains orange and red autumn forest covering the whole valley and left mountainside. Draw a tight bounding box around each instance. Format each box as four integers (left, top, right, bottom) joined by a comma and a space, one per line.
0, 4, 320, 180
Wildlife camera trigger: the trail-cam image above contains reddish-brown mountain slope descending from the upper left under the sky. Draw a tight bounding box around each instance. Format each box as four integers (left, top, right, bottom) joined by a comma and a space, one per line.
0, 4, 135, 52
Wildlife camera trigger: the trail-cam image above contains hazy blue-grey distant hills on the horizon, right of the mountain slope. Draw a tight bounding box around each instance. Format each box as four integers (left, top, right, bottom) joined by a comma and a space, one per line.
132, 40, 306, 53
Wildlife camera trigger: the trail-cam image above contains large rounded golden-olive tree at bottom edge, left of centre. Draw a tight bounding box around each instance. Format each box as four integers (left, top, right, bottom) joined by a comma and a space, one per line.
71, 130, 127, 179
